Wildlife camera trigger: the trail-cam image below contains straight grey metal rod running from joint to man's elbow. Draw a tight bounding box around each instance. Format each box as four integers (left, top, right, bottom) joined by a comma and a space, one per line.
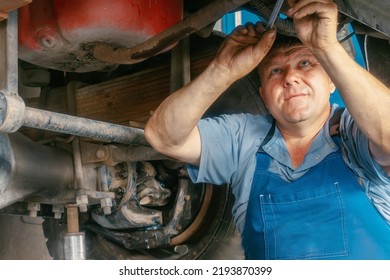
23, 107, 149, 146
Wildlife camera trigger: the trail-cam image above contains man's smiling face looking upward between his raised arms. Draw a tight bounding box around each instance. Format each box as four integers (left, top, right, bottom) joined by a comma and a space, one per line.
259, 45, 335, 128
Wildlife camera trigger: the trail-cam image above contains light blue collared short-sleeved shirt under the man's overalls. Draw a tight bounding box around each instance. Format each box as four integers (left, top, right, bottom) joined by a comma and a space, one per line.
187, 105, 390, 232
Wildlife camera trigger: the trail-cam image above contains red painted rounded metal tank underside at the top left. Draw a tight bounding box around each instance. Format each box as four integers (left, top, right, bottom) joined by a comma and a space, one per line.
19, 0, 183, 72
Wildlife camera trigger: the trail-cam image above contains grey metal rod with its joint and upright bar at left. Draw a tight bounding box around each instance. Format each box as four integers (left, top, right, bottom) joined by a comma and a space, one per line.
0, 11, 149, 146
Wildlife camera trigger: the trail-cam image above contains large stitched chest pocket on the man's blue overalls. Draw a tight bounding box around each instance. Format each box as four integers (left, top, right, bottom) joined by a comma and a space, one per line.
259, 182, 348, 259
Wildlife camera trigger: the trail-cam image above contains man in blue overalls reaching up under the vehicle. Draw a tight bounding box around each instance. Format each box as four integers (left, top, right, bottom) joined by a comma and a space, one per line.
145, 0, 390, 259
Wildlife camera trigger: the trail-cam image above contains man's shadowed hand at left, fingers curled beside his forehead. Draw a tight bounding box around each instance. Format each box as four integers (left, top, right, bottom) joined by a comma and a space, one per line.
214, 22, 276, 80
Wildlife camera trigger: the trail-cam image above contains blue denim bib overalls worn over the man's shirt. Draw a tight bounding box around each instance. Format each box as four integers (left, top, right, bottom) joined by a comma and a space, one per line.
242, 122, 390, 259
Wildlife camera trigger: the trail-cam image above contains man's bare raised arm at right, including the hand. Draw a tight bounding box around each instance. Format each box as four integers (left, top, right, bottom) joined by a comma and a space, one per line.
288, 0, 390, 174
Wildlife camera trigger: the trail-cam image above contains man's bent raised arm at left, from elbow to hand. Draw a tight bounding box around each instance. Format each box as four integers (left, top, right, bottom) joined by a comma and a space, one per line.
145, 23, 275, 164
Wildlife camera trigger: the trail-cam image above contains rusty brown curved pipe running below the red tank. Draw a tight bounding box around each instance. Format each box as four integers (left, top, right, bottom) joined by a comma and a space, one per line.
93, 0, 249, 64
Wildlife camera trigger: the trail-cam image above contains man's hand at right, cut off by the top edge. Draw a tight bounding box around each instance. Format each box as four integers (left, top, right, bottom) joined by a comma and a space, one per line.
287, 0, 338, 52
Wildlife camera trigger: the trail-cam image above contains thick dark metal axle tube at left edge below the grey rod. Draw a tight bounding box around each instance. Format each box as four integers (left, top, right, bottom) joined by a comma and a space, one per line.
0, 133, 74, 209
